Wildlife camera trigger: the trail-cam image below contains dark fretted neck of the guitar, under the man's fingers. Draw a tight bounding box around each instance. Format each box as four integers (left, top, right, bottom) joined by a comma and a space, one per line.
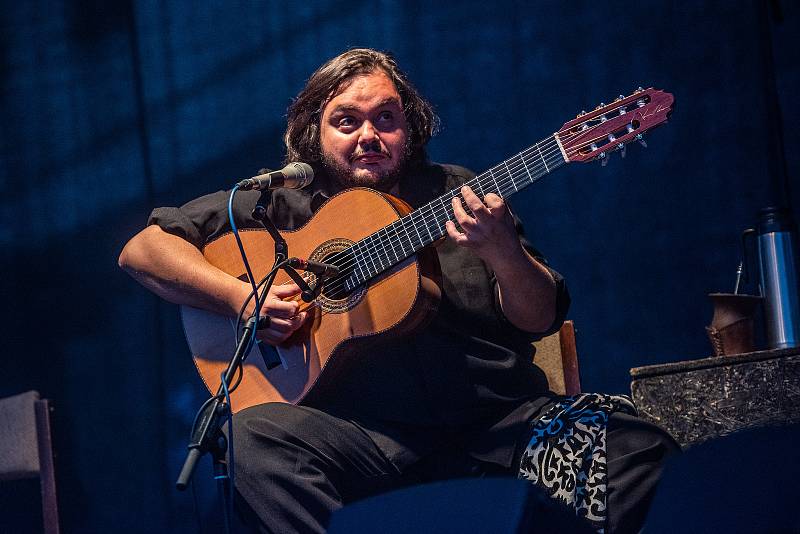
347, 135, 567, 287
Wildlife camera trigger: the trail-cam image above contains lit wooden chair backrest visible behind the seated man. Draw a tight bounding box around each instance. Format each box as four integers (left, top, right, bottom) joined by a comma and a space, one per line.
533, 321, 581, 395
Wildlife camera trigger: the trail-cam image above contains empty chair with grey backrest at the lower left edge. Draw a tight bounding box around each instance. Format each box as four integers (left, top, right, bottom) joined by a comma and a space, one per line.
0, 391, 59, 534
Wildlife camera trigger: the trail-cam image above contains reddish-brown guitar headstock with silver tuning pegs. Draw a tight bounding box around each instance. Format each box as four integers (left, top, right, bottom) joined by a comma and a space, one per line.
556, 87, 675, 165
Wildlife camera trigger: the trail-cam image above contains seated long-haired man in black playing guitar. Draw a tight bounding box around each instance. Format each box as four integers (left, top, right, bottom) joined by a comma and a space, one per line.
120, 49, 670, 532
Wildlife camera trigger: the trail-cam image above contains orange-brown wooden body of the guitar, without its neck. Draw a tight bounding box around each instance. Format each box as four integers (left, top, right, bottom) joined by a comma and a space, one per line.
181, 188, 441, 412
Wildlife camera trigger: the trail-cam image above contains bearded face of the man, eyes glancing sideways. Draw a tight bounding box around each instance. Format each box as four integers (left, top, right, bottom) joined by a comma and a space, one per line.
320, 71, 408, 191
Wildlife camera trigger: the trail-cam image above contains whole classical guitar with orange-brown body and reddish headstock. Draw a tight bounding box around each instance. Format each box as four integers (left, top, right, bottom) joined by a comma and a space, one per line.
181, 88, 673, 411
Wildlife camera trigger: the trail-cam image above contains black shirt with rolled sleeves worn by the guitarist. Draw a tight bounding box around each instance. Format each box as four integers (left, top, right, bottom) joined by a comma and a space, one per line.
148, 164, 569, 470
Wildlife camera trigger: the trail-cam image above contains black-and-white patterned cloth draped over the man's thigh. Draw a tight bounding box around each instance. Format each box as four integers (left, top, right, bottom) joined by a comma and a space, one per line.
517, 393, 637, 533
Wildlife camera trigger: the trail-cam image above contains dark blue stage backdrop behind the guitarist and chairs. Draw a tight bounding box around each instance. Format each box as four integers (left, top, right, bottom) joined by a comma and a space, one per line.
0, 0, 800, 533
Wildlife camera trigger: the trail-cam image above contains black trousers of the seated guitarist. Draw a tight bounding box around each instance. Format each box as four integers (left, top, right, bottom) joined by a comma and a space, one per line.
234, 404, 678, 534
